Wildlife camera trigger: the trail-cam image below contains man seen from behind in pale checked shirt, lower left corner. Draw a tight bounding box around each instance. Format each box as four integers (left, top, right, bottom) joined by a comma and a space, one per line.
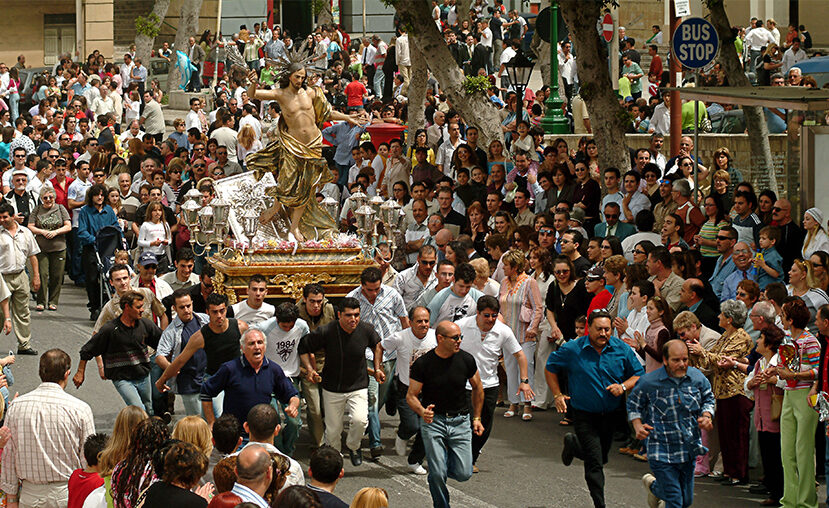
0, 349, 95, 508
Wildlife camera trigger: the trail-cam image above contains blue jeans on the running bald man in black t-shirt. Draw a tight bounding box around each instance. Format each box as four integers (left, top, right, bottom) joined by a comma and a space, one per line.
420, 414, 472, 508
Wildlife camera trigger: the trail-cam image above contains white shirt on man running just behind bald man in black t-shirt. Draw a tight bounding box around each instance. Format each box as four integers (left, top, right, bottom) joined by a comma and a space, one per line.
455, 315, 521, 390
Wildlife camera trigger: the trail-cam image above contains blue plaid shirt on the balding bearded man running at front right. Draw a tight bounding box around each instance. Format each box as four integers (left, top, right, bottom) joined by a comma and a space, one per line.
627, 366, 715, 464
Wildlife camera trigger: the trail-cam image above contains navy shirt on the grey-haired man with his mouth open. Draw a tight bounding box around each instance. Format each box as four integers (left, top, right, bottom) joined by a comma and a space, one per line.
199, 356, 299, 430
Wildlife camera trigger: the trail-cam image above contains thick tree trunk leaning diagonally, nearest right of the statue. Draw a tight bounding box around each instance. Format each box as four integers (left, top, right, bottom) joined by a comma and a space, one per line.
394, 0, 502, 150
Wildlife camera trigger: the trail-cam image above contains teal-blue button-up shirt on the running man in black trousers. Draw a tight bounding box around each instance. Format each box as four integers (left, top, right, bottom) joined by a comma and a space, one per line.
547, 335, 645, 413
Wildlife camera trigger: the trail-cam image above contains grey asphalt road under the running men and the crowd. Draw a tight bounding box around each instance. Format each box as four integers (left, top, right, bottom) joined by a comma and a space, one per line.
12, 279, 812, 508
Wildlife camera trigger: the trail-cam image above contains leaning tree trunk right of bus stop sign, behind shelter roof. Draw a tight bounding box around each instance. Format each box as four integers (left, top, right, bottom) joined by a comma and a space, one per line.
707, 0, 778, 194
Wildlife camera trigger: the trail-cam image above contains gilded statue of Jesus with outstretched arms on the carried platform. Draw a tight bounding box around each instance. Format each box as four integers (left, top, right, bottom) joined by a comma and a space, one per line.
245, 63, 363, 242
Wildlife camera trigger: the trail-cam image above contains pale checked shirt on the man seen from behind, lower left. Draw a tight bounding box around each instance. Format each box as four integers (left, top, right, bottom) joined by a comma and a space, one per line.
0, 383, 95, 493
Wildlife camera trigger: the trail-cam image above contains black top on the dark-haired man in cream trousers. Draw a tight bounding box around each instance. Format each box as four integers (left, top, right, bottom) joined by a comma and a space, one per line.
297, 321, 380, 393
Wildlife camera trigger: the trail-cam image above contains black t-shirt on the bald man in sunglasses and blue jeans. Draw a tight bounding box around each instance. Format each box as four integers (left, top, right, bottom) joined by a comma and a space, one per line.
410, 349, 478, 414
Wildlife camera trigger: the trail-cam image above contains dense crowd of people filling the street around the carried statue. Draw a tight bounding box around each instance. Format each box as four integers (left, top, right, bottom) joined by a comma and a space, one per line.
0, 0, 829, 507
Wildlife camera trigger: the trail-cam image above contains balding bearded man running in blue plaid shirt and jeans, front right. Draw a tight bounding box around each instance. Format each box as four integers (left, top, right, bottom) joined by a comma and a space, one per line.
627, 340, 715, 508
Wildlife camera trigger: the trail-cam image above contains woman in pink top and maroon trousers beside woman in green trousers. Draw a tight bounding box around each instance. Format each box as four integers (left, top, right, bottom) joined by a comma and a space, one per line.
745, 326, 784, 506
